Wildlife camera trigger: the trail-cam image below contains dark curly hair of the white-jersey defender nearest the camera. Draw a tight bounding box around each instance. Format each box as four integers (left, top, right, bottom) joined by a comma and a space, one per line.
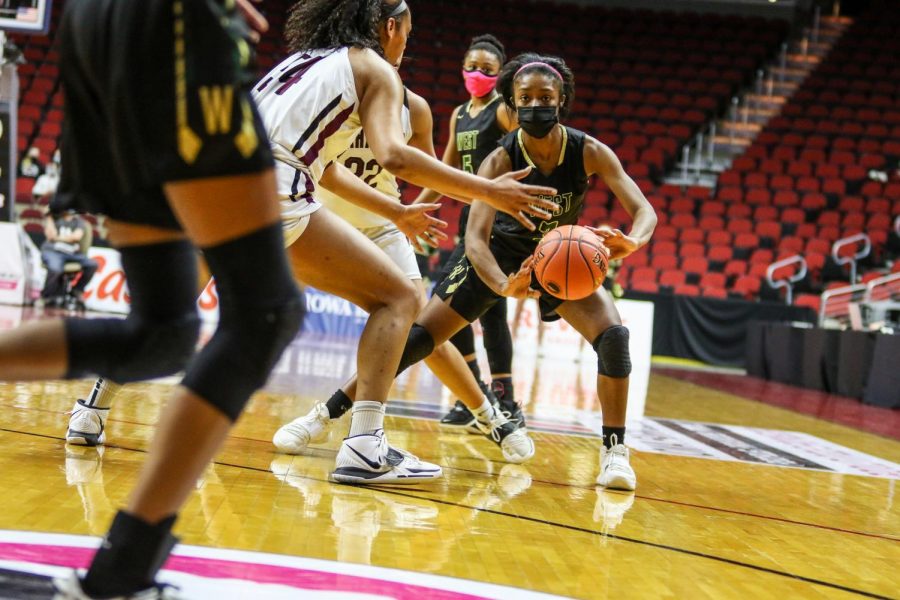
284, 0, 409, 54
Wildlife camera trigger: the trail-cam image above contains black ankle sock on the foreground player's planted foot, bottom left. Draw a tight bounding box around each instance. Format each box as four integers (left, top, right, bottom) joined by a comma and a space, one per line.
81, 511, 178, 598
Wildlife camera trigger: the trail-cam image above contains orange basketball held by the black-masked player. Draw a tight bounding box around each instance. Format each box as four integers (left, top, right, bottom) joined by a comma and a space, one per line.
534, 225, 609, 300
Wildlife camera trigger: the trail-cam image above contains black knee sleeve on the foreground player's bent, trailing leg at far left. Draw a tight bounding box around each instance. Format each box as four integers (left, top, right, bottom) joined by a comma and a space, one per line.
65, 241, 200, 383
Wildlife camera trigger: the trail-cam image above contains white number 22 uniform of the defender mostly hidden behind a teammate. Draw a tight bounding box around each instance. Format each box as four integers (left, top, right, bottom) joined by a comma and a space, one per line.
314, 92, 412, 229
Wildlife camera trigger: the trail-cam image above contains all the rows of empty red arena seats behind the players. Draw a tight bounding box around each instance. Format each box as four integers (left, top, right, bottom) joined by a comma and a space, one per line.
7, 0, 900, 310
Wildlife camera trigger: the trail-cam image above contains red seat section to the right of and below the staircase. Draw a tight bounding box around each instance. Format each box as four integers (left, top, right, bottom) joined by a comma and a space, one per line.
608, 6, 900, 308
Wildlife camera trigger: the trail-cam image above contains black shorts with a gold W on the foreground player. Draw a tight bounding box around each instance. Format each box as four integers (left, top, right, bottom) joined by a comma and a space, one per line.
59, 0, 273, 229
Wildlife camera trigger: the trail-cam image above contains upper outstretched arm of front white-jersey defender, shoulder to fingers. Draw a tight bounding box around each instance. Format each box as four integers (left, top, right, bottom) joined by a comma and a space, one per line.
350, 50, 555, 229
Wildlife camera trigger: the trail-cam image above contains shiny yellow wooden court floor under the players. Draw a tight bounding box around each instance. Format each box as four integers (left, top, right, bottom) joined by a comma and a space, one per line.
0, 330, 900, 598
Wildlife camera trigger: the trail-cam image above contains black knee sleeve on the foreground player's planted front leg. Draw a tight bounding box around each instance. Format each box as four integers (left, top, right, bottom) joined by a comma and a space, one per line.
183, 224, 305, 420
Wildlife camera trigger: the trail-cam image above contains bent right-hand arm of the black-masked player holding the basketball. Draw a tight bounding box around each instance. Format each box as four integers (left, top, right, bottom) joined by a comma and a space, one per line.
584, 136, 657, 259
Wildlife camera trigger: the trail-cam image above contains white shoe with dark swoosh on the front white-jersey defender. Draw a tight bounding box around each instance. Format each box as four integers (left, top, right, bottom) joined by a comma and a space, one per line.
331, 429, 443, 484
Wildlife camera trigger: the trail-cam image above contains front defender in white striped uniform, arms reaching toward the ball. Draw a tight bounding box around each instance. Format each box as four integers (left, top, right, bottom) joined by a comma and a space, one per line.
67, 0, 552, 483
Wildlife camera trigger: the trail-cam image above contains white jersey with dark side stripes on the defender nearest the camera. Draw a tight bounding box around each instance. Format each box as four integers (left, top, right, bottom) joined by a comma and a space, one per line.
253, 48, 362, 218
